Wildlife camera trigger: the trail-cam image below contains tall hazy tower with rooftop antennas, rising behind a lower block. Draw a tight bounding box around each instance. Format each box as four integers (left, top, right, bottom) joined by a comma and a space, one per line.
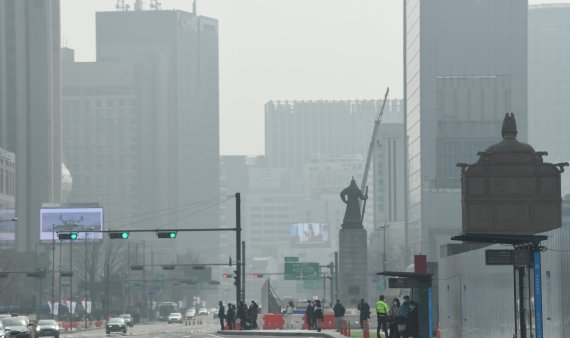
96, 10, 220, 257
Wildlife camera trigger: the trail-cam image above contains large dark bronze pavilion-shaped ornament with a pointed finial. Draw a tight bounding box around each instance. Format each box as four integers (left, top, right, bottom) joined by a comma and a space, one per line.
457, 113, 568, 235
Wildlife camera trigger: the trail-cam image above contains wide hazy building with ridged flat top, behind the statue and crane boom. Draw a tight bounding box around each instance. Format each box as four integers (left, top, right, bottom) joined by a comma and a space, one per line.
265, 100, 401, 174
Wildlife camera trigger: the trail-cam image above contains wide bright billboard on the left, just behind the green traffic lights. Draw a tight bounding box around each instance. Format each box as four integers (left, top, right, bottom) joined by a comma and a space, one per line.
40, 208, 103, 241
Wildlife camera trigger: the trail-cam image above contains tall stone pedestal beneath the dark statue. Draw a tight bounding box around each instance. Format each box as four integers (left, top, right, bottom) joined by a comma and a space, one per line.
339, 227, 369, 306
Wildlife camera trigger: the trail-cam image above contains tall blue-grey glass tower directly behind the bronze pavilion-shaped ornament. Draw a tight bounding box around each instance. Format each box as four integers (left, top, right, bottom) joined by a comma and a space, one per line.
404, 0, 528, 260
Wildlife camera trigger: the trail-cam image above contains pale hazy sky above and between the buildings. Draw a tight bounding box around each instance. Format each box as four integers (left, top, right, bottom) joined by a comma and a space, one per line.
61, 0, 560, 155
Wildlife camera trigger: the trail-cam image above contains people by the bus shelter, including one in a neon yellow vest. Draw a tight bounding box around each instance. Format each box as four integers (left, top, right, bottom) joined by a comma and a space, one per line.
358, 295, 419, 338
